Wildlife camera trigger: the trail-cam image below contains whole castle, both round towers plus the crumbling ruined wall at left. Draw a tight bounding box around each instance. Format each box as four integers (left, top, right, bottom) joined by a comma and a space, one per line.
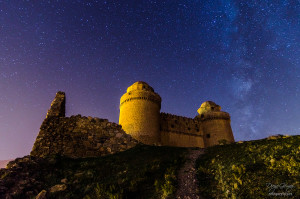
30, 81, 234, 158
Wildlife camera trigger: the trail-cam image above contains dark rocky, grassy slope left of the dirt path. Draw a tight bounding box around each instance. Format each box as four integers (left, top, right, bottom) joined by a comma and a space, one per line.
0, 145, 187, 199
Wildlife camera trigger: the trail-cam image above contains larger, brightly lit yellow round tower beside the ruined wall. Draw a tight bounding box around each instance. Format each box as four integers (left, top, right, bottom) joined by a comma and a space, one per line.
119, 81, 161, 144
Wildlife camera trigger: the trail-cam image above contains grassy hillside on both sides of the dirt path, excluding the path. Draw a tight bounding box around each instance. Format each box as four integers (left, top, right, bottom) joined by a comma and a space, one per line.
0, 136, 300, 199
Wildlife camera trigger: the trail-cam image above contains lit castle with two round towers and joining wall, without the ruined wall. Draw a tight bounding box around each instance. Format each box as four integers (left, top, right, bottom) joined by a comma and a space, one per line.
119, 81, 234, 148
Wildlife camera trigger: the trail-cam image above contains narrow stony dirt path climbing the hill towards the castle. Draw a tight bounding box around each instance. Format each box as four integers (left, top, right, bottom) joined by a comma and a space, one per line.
176, 149, 204, 199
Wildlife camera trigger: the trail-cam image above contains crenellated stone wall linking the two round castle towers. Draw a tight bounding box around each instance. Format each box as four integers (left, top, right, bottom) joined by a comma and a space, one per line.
160, 113, 204, 148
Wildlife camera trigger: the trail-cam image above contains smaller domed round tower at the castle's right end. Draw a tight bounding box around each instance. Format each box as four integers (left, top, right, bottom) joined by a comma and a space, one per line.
196, 101, 234, 147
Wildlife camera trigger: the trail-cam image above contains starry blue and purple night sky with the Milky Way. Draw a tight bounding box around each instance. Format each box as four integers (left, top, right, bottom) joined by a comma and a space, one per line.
0, 0, 300, 159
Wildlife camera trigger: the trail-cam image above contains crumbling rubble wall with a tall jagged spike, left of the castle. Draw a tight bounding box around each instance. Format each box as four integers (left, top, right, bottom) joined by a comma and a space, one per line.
31, 92, 137, 158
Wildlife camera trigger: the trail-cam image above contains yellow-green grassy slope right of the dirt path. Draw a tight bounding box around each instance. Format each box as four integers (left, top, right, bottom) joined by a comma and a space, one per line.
197, 136, 300, 198
